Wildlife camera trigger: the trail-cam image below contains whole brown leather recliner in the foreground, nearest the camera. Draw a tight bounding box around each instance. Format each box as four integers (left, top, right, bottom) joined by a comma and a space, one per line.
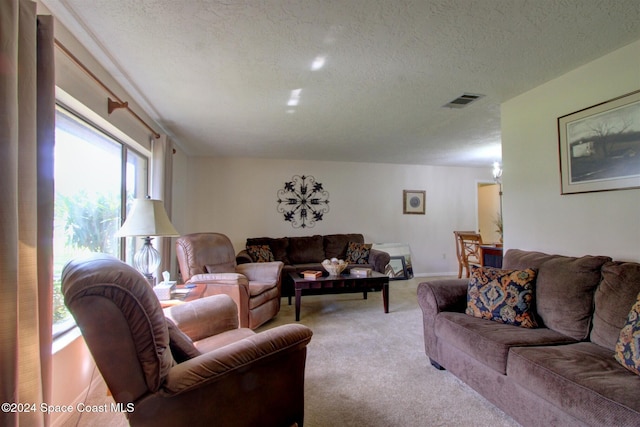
62, 254, 312, 427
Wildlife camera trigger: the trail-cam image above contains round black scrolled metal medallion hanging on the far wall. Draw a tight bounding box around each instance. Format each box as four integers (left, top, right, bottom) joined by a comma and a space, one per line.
277, 175, 329, 228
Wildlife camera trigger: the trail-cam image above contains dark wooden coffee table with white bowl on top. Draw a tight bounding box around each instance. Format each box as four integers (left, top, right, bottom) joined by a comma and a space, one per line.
289, 271, 389, 322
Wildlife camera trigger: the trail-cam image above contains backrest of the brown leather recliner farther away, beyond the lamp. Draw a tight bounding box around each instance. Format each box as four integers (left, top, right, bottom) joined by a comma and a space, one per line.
176, 233, 236, 282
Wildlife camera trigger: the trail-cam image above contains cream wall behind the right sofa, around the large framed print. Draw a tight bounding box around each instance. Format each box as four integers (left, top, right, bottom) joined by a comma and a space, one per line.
502, 41, 640, 261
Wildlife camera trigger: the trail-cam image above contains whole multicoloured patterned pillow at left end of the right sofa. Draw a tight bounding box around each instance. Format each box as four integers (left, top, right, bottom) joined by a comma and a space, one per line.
465, 266, 538, 328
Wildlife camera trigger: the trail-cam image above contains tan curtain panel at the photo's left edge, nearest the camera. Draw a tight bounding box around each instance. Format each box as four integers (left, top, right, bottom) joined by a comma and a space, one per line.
0, 0, 55, 426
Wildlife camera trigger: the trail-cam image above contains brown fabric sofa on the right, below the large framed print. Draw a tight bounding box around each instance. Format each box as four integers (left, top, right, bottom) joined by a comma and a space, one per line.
418, 249, 640, 426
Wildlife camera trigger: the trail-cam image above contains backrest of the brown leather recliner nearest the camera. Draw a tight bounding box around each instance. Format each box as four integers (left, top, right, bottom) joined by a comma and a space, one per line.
62, 254, 175, 403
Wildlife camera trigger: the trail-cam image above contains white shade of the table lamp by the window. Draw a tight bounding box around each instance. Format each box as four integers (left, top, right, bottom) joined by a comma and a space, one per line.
117, 199, 180, 237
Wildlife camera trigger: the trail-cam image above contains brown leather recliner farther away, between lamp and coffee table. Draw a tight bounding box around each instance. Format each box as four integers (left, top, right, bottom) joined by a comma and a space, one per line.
176, 233, 284, 329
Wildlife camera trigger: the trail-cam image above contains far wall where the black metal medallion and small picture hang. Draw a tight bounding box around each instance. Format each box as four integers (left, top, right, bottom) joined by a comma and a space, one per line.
173, 156, 491, 275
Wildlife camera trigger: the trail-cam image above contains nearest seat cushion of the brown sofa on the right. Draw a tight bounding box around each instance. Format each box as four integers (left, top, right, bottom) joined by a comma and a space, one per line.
507, 342, 640, 426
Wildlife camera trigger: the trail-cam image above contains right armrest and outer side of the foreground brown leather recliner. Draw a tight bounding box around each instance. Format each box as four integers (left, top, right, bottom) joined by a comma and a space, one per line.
134, 324, 312, 427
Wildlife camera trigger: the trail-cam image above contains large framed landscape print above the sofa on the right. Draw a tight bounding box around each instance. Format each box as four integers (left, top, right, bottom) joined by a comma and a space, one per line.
558, 90, 640, 195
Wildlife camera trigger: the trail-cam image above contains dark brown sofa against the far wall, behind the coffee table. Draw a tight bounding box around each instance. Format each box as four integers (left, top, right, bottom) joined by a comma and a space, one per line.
236, 234, 391, 297
